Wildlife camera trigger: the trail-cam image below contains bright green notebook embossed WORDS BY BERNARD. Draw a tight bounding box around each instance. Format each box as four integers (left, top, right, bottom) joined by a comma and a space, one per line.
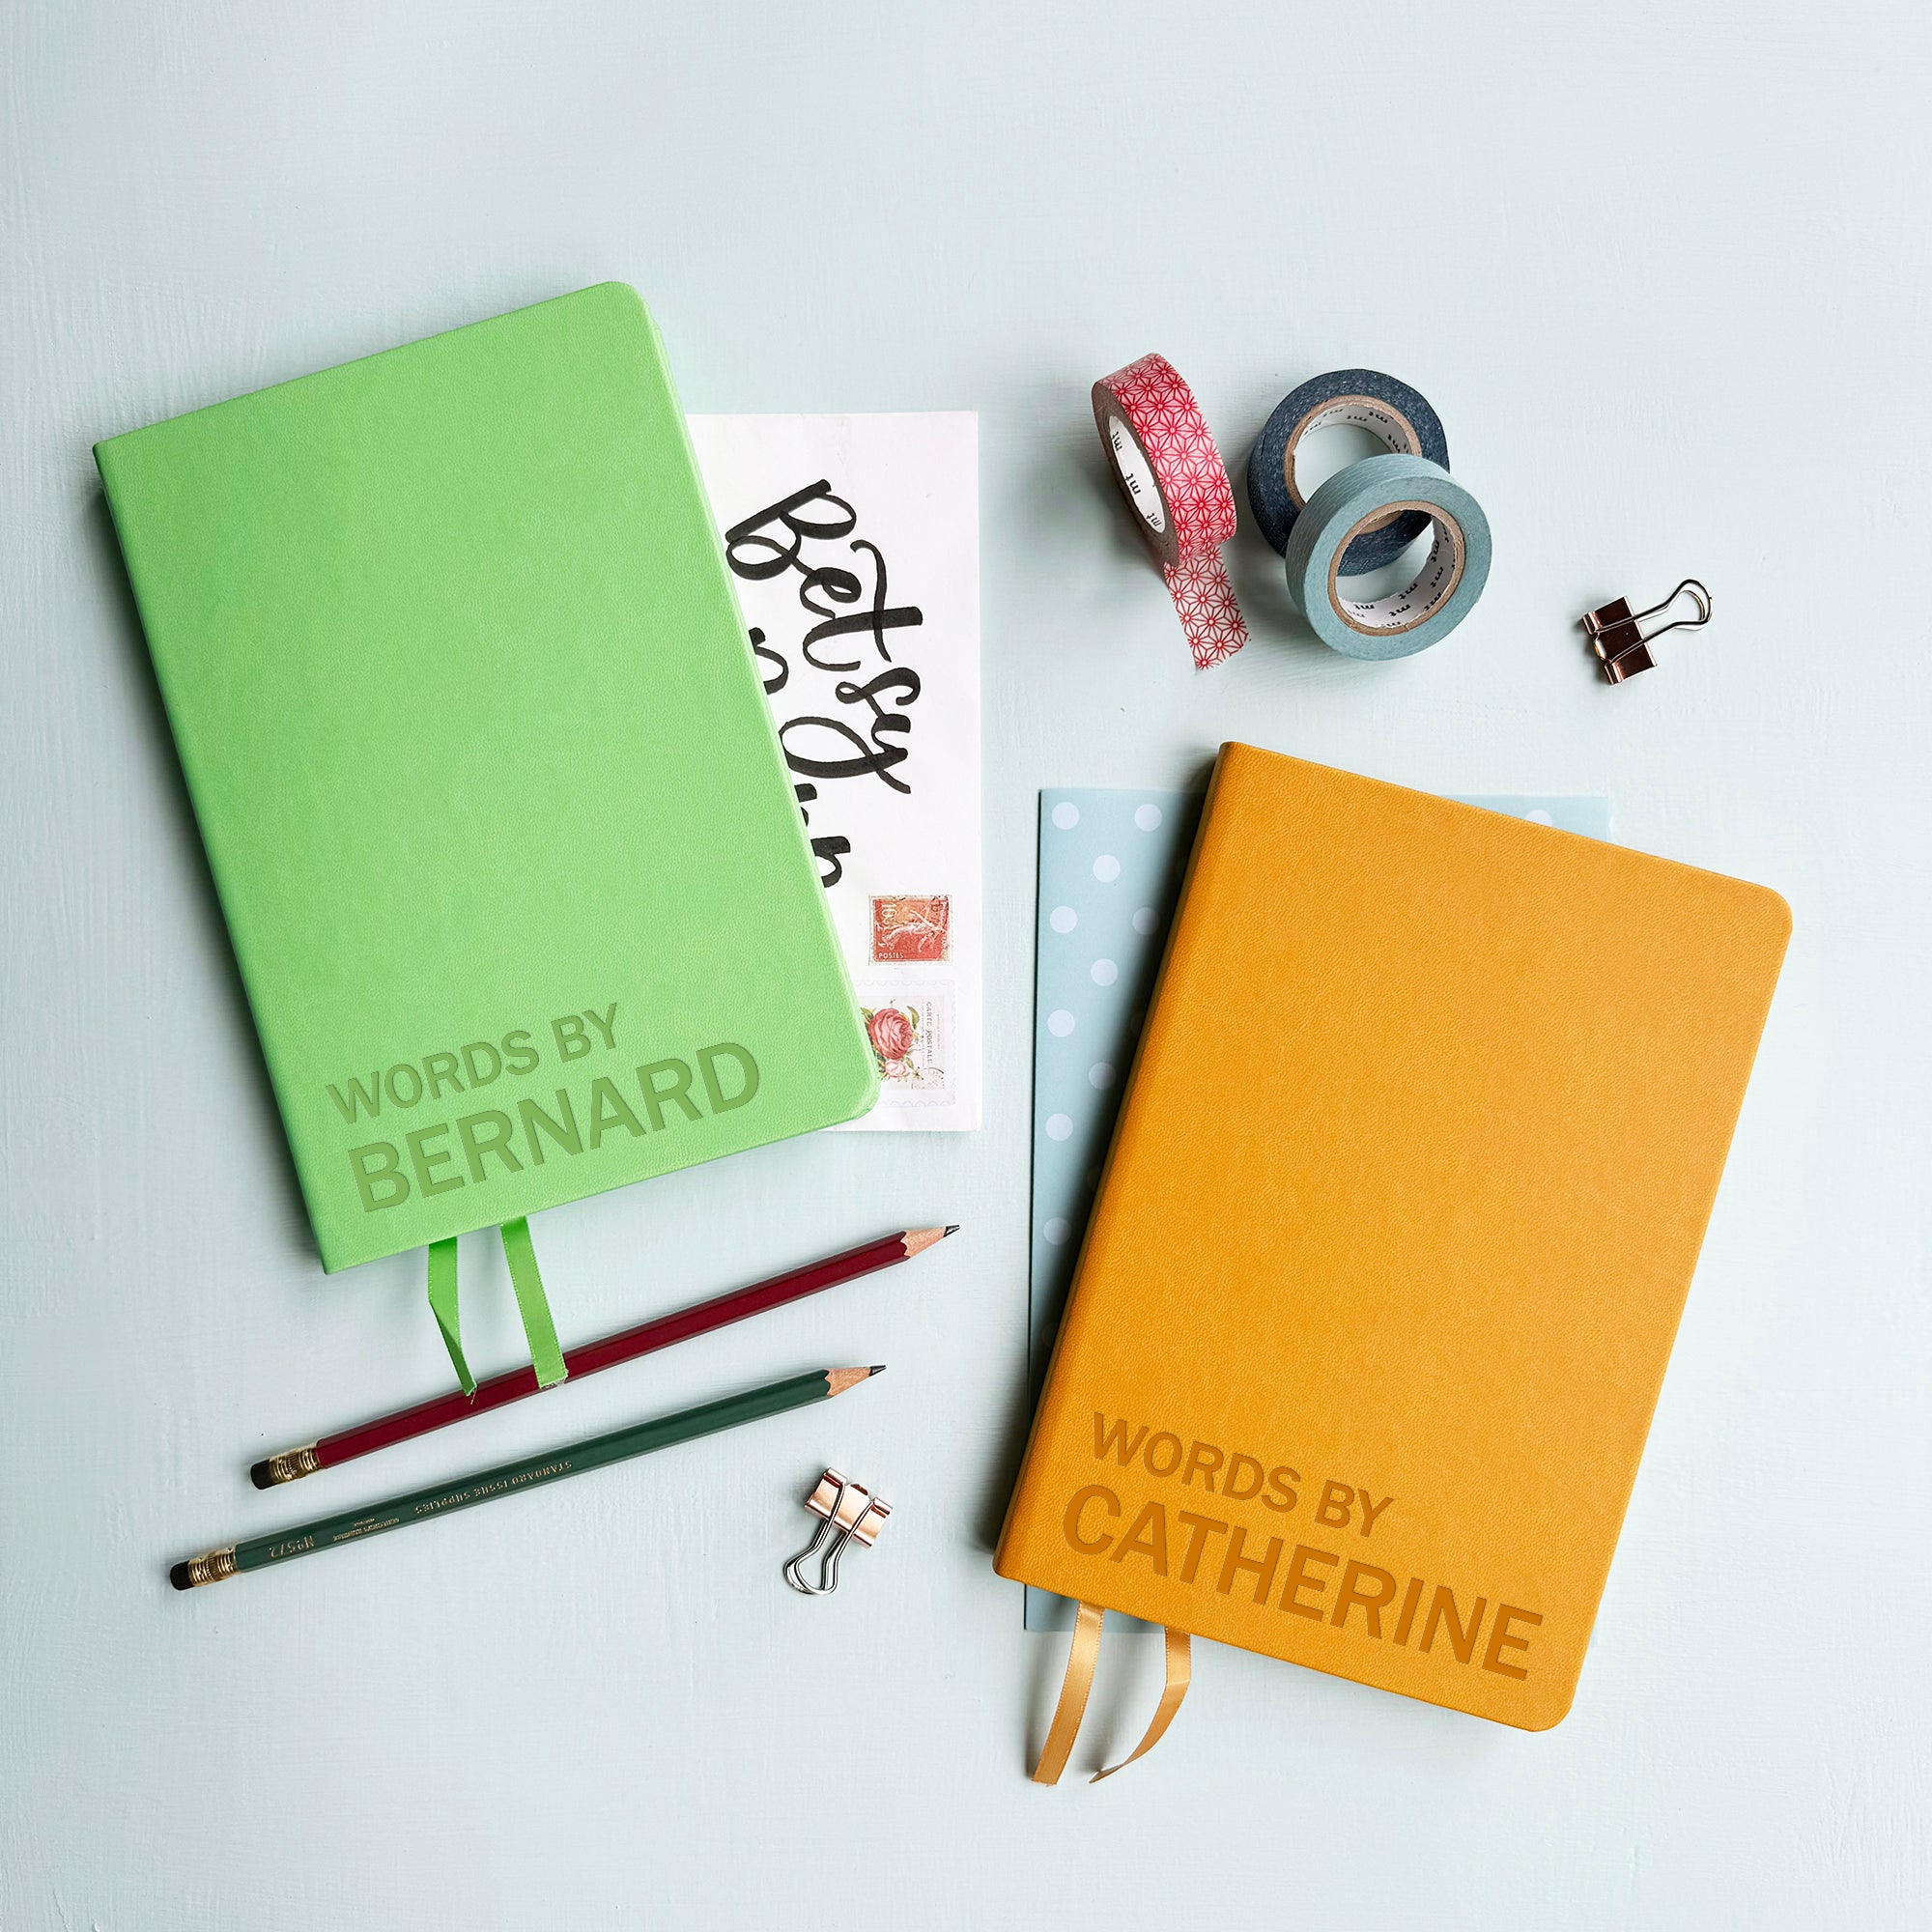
95, 282, 877, 1352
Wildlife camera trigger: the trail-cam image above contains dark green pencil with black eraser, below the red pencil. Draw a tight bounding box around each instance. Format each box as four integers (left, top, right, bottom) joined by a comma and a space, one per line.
168, 1362, 885, 1590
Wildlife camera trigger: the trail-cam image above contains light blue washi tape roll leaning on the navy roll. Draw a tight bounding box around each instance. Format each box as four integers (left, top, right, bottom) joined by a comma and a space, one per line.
1287, 456, 1490, 659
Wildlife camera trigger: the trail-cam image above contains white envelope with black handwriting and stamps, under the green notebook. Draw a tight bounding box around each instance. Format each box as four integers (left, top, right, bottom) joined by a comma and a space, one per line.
688, 412, 981, 1132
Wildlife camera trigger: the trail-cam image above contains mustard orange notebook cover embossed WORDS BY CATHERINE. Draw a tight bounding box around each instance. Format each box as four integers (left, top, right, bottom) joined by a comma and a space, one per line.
997, 744, 1791, 1731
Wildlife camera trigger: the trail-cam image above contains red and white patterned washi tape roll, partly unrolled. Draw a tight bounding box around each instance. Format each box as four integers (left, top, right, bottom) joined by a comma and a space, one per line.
1094, 355, 1248, 670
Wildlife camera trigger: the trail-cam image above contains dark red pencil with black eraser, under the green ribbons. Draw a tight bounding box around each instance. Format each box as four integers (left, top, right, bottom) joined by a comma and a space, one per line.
249, 1227, 956, 1490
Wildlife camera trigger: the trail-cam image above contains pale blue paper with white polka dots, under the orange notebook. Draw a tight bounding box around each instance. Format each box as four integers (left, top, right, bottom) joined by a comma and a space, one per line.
1026, 788, 1609, 1631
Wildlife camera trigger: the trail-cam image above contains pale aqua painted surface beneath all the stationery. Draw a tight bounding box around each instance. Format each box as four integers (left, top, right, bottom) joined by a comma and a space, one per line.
0, 0, 1932, 1932
